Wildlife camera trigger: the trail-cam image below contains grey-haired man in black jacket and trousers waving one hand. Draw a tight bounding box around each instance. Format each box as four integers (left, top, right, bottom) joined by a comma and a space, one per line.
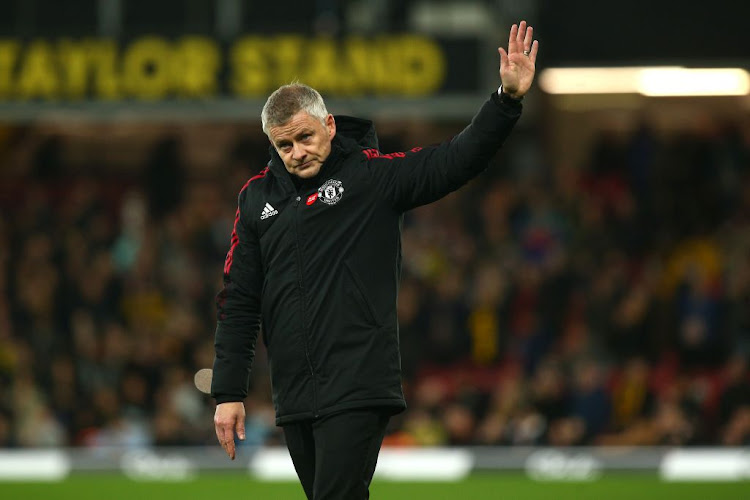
211, 21, 538, 500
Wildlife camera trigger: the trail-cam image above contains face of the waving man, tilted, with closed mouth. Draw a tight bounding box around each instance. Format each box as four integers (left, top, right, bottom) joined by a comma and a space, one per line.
268, 111, 336, 179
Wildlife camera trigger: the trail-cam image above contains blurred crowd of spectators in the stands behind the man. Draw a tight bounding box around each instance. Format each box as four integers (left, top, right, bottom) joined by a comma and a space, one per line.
0, 113, 750, 447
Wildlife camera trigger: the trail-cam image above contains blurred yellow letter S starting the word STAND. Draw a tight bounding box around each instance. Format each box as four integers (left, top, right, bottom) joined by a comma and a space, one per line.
235, 36, 273, 97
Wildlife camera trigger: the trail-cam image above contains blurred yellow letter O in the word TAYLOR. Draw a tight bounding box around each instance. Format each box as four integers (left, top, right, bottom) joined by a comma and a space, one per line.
122, 37, 171, 100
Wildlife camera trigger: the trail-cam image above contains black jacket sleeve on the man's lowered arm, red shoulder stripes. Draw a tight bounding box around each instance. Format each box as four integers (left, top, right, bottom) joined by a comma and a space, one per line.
211, 186, 263, 403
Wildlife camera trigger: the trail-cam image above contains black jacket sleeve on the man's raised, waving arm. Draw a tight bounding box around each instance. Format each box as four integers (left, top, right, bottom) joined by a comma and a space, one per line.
365, 92, 522, 211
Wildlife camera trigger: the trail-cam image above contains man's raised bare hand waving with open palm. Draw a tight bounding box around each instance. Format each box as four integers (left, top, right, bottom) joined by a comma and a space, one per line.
497, 21, 539, 99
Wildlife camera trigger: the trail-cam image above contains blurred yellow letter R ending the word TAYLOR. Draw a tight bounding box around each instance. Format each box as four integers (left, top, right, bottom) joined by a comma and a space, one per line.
173, 36, 221, 97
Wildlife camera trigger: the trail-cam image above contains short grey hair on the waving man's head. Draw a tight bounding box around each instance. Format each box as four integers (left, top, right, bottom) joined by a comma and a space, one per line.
260, 82, 328, 137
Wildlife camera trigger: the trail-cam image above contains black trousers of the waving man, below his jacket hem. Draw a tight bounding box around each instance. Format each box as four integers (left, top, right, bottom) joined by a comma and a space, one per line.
284, 408, 390, 500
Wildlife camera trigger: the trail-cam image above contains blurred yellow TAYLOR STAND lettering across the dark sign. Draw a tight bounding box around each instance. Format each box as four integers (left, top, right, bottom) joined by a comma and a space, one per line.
0, 35, 446, 101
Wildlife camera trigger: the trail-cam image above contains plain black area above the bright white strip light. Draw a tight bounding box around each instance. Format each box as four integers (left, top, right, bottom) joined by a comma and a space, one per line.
536, 0, 750, 67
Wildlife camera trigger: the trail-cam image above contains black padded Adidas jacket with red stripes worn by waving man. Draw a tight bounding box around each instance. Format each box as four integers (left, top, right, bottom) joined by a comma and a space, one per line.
211, 94, 521, 425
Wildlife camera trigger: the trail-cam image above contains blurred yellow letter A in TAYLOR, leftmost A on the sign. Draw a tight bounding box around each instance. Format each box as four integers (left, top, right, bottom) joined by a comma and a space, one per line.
17, 40, 60, 99
